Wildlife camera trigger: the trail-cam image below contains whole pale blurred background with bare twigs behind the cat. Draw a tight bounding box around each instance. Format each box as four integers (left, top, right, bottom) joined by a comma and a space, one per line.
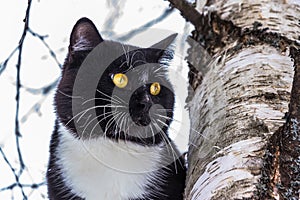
0, 0, 191, 200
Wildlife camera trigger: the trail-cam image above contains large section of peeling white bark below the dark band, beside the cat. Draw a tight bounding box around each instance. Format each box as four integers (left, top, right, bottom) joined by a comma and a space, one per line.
186, 45, 293, 200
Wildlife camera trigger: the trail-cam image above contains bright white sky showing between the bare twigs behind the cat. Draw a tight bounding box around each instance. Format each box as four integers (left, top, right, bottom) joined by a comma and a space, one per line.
0, 0, 188, 200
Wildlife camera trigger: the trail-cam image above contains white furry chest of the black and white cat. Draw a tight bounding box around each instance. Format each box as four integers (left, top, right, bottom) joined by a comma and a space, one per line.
57, 125, 162, 200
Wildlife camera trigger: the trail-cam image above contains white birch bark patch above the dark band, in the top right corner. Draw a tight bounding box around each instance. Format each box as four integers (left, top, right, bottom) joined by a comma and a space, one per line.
206, 0, 300, 42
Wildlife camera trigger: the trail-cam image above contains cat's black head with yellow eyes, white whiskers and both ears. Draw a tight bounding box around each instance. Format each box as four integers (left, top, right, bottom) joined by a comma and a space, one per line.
55, 18, 175, 145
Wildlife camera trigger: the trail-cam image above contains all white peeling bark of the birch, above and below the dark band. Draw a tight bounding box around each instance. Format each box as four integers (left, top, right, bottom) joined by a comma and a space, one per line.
186, 0, 300, 200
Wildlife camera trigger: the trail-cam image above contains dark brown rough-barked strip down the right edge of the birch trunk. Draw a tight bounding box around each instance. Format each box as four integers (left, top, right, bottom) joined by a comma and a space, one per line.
279, 47, 300, 199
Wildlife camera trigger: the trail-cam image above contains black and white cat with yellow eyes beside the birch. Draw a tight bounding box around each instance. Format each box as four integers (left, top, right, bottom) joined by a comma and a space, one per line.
47, 18, 186, 200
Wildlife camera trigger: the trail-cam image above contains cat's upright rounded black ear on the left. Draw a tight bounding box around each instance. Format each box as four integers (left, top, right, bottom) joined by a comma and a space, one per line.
69, 17, 103, 52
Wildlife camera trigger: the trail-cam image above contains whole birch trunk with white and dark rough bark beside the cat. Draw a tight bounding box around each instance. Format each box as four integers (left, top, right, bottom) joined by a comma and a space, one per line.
169, 0, 300, 200
